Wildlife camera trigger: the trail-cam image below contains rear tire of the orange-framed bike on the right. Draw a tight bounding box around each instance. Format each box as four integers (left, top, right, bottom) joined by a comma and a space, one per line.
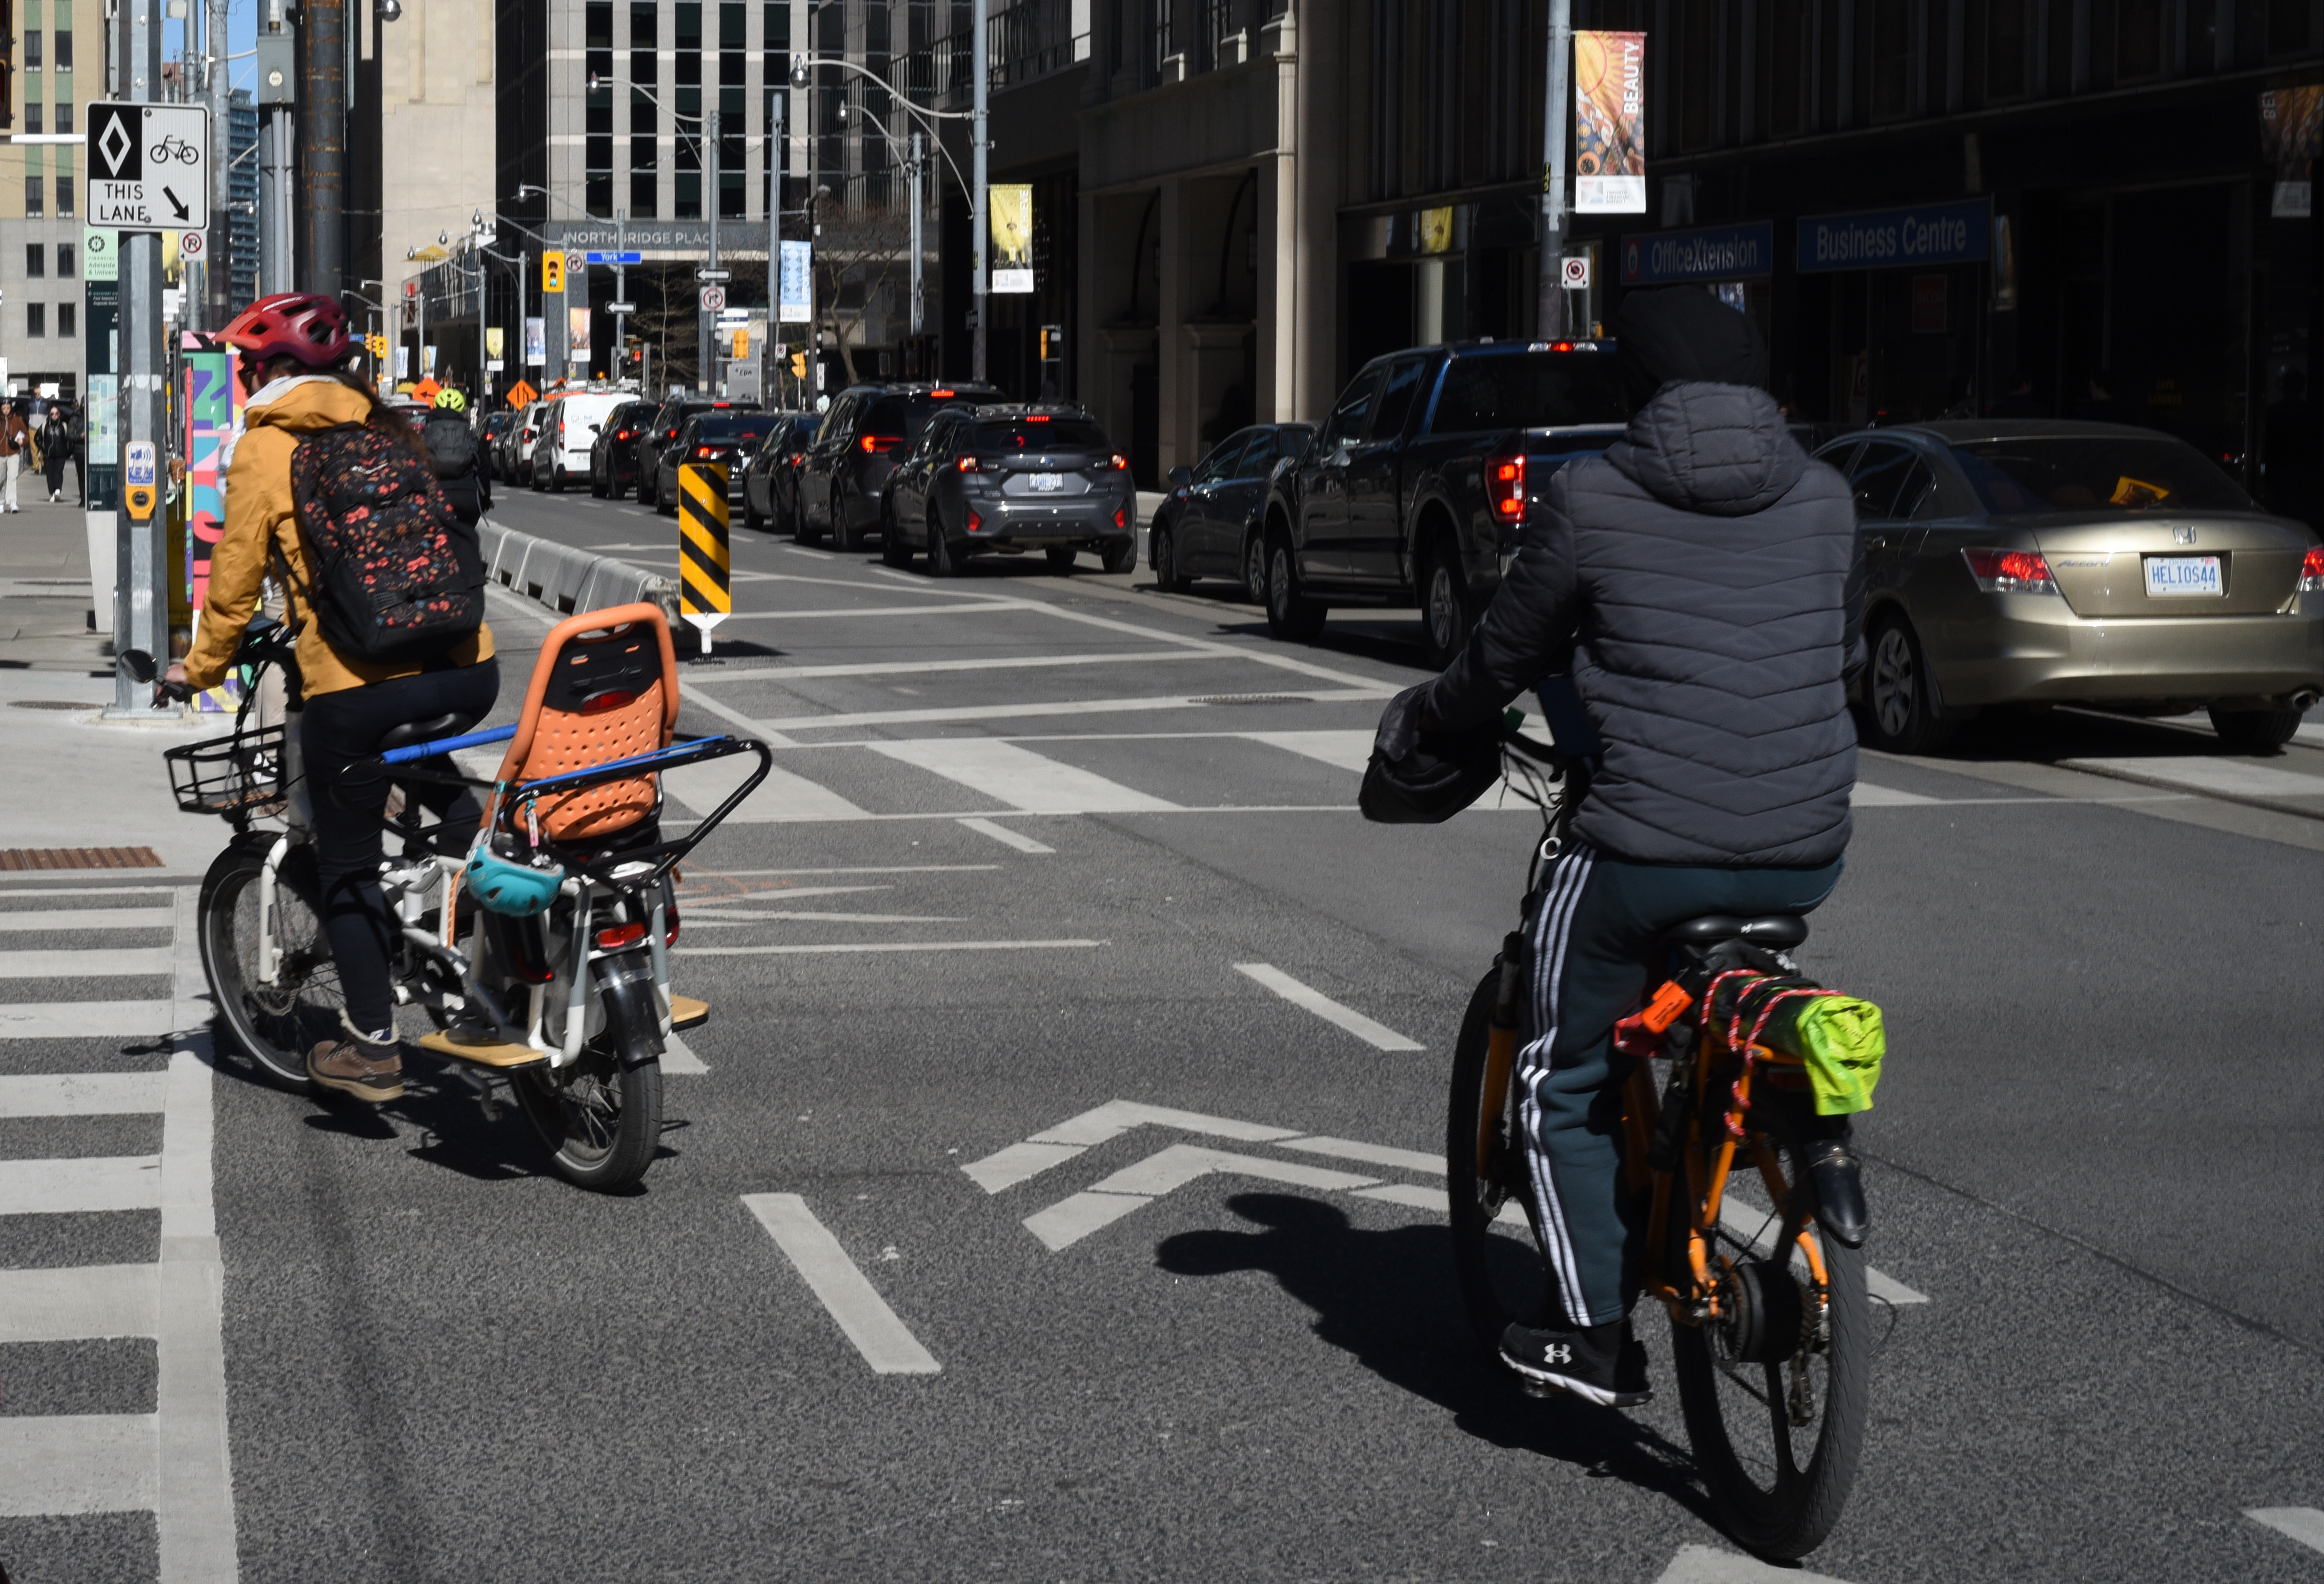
1671, 1110, 1873, 1561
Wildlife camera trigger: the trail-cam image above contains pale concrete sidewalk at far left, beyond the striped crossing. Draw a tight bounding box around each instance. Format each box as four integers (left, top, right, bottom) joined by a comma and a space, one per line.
0, 484, 228, 879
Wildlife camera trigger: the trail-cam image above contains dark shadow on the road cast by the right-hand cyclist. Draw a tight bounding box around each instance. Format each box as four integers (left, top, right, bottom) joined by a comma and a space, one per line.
1155, 1193, 1718, 1528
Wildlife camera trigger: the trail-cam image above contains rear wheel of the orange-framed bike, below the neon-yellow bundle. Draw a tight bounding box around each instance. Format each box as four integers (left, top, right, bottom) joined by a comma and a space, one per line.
1671, 1107, 1873, 1561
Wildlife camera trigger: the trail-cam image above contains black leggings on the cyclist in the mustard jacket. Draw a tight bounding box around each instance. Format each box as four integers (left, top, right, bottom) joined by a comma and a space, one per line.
300, 661, 500, 1033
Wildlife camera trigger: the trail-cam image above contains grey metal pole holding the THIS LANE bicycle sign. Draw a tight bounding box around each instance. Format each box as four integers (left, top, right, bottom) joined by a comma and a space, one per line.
111, 0, 170, 716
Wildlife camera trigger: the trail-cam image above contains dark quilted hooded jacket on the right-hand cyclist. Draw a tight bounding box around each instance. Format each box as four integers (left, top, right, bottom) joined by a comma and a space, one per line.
1427, 381, 1861, 868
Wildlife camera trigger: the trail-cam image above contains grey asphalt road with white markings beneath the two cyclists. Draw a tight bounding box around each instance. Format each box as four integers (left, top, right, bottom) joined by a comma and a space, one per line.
0, 476, 2324, 1584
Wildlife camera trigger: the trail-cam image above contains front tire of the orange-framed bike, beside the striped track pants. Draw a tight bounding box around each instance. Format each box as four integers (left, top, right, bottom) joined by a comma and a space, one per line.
1446, 965, 1557, 1361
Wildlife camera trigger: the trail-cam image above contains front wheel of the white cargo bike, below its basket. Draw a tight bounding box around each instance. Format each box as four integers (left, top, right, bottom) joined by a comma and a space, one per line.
195, 833, 344, 1093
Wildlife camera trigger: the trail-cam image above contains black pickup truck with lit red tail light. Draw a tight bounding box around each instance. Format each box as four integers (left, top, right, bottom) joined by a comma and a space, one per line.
1267, 342, 1627, 665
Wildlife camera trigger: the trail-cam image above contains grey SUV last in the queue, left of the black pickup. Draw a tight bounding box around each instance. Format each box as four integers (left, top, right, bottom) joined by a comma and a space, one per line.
881, 405, 1139, 577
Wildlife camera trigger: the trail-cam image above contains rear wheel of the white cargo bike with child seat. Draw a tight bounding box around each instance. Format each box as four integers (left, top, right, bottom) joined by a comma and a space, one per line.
509, 963, 662, 1193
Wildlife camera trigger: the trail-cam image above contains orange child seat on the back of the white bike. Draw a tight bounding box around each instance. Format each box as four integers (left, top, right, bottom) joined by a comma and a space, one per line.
495, 605, 679, 842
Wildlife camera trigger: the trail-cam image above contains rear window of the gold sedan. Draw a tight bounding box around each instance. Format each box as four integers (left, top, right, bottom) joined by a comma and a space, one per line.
1952, 435, 2256, 514
